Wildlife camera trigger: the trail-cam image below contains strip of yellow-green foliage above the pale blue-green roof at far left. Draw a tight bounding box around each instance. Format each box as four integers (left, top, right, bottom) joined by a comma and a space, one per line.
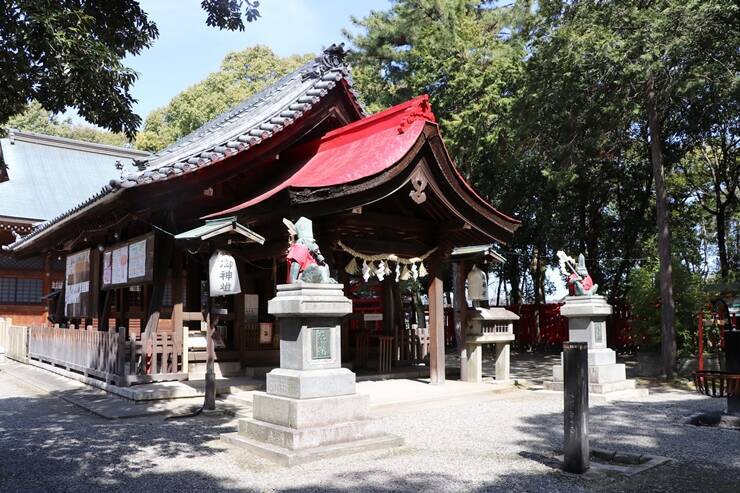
7, 101, 128, 146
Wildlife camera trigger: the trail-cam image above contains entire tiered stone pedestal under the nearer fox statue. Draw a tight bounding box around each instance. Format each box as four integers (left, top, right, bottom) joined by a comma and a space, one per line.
222, 281, 403, 465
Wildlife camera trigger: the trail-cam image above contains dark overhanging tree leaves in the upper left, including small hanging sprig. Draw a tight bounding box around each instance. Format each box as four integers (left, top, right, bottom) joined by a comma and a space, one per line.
0, 0, 266, 139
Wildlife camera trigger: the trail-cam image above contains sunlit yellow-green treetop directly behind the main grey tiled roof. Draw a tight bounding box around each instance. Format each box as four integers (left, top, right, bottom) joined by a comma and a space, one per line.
136, 46, 313, 151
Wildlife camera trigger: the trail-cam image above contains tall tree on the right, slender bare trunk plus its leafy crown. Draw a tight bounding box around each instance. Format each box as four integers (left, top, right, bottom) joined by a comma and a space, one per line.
532, 0, 740, 376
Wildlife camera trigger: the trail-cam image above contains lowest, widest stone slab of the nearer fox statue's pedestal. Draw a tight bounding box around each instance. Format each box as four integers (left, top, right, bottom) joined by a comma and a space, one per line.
221, 433, 403, 466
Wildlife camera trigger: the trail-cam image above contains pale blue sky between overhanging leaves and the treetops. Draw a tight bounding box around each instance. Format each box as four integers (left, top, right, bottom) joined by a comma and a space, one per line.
124, 0, 391, 119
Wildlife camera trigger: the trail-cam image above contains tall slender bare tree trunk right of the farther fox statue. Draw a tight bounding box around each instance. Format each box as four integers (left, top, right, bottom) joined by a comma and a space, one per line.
647, 76, 676, 378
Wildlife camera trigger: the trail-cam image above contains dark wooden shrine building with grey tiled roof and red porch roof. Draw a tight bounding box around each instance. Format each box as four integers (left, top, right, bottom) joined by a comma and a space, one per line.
6, 46, 519, 385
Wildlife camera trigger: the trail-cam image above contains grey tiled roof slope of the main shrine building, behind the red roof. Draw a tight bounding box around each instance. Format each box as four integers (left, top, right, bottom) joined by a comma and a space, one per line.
4, 44, 365, 250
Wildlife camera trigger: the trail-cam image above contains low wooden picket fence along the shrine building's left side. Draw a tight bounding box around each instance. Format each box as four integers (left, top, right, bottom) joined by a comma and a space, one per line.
28, 326, 187, 386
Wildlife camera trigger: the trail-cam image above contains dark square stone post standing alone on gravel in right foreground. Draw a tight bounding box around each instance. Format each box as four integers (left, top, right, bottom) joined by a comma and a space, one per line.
563, 342, 590, 474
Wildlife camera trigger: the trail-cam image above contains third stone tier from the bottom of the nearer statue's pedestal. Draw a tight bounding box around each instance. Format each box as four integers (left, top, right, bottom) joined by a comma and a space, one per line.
252, 392, 370, 429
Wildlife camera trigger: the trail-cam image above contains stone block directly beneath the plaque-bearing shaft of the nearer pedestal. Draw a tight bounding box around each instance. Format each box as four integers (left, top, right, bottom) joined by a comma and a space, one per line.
267, 368, 355, 399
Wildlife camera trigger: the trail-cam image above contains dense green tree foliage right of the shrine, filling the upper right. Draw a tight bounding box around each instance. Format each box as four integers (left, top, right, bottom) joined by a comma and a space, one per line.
346, 0, 740, 308
